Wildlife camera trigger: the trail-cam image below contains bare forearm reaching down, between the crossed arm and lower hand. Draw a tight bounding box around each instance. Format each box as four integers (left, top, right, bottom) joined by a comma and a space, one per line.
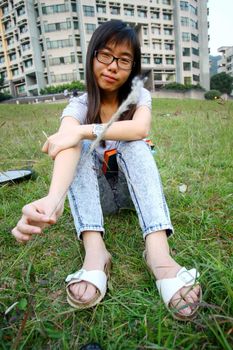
49, 145, 81, 201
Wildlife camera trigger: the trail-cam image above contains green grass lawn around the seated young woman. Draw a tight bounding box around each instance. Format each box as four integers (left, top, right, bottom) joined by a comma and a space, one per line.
0, 99, 233, 350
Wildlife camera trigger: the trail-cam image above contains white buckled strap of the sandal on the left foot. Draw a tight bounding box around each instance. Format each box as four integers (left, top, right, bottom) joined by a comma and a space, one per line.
65, 269, 107, 295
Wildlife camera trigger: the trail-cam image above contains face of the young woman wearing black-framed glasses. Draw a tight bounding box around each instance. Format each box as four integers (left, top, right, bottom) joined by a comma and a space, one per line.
93, 43, 134, 92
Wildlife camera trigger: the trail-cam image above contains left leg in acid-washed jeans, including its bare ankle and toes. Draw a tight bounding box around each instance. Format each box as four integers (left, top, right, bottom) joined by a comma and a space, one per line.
68, 142, 110, 302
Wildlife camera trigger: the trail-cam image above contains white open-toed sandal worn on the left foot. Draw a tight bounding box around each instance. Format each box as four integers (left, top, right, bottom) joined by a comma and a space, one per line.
66, 260, 111, 309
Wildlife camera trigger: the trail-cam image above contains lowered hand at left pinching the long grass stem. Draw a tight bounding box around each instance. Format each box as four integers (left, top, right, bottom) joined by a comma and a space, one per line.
11, 196, 64, 243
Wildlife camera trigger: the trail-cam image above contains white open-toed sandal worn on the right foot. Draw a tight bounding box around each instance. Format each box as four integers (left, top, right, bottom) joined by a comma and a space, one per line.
156, 267, 202, 321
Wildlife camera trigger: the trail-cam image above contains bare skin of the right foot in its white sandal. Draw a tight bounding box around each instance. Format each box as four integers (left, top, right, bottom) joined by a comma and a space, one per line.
146, 253, 200, 316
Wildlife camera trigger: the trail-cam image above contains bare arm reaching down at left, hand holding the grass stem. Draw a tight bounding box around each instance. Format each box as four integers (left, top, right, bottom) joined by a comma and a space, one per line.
12, 121, 81, 243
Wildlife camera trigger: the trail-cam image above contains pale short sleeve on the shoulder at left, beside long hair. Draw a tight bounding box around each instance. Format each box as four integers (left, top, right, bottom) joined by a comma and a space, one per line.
61, 94, 87, 124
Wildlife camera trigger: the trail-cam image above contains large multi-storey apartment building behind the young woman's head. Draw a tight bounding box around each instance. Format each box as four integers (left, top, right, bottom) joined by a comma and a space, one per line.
0, 0, 209, 96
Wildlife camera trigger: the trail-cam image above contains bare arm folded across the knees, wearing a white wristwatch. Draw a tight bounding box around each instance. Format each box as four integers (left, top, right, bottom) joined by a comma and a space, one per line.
42, 106, 151, 159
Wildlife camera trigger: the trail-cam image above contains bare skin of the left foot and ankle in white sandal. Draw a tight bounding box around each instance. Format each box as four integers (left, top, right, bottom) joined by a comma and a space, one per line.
69, 249, 111, 303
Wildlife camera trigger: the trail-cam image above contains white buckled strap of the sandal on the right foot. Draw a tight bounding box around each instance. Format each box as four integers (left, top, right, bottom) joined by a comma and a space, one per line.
156, 267, 200, 306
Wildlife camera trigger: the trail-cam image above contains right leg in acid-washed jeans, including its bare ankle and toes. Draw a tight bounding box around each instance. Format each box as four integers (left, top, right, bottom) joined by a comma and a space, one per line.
118, 141, 199, 315
